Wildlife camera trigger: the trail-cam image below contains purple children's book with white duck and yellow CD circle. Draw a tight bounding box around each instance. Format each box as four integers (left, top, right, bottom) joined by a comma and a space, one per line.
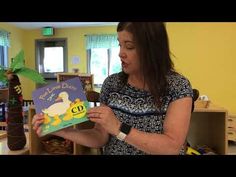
32, 77, 89, 136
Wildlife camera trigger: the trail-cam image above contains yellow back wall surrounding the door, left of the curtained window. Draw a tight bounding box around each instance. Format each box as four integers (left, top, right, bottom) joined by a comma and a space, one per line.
22, 26, 116, 99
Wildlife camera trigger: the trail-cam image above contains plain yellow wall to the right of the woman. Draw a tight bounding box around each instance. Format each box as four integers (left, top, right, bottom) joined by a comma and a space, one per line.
167, 23, 236, 113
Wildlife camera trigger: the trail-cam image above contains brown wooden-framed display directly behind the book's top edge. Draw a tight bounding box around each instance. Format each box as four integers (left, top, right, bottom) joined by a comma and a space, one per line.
57, 73, 94, 91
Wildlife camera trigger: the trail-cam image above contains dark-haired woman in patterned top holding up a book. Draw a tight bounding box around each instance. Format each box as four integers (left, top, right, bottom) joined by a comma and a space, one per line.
33, 22, 193, 155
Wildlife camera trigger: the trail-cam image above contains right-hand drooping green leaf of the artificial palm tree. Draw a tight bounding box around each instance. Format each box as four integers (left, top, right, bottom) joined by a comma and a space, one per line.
16, 67, 46, 84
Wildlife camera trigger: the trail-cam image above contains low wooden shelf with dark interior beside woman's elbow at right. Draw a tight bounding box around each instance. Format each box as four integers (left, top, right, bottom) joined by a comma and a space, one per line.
187, 106, 228, 155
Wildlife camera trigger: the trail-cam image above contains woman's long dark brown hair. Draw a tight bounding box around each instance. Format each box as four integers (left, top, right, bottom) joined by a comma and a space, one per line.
117, 22, 174, 105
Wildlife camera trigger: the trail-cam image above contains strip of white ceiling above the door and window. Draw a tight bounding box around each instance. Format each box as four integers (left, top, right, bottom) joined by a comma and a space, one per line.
8, 22, 118, 29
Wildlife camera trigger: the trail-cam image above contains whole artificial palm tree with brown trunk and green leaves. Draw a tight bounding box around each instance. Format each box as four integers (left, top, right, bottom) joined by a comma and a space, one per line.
0, 50, 45, 150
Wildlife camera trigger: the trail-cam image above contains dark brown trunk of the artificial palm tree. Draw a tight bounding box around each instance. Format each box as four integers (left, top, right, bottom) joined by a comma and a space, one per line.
7, 74, 26, 150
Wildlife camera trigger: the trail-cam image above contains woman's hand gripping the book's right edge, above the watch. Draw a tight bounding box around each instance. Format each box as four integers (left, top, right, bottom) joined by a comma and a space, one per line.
87, 105, 121, 135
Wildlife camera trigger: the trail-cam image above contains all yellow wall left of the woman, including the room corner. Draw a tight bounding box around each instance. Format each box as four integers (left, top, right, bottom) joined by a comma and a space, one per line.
0, 23, 116, 99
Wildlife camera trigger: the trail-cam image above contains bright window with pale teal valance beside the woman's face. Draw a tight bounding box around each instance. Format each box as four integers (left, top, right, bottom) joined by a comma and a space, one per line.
86, 35, 121, 87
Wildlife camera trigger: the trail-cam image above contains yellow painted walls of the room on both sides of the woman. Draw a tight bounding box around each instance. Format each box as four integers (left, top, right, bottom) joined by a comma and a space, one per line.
0, 22, 236, 113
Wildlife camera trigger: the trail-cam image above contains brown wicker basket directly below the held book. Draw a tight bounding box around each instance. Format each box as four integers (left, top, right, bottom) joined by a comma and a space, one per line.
42, 137, 73, 155
